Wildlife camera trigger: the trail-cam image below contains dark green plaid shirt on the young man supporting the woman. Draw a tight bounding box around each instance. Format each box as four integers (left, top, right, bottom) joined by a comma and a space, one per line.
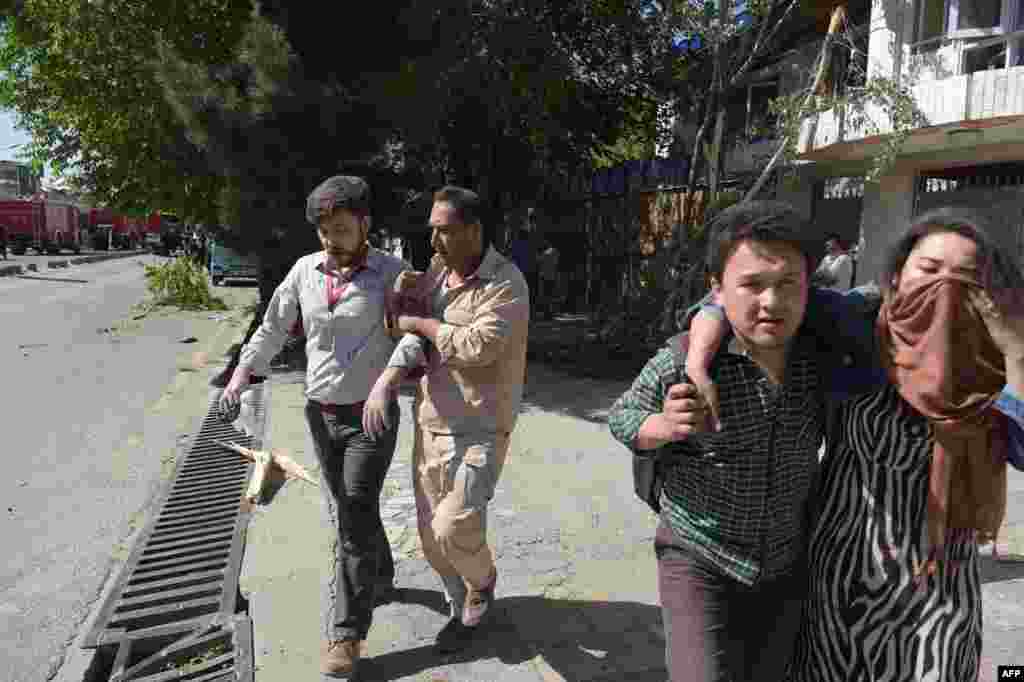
608, 337, 824, 585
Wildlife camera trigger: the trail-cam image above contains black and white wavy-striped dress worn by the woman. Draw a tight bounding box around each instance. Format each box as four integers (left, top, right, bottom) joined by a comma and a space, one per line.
792, 385, 982, 682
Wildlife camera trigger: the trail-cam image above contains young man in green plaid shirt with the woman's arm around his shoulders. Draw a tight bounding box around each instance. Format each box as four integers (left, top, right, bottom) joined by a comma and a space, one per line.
608, 202, 824, 682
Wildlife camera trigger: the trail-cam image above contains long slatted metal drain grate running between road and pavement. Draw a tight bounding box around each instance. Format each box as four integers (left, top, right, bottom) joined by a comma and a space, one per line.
83, 384, 265, 647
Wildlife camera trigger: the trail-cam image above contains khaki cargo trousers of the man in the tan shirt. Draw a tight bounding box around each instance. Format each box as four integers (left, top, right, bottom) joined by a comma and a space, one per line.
413, 424, 509, 603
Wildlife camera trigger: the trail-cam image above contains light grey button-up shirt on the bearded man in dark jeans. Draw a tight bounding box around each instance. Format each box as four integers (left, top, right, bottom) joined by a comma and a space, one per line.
239, 248, 412, 404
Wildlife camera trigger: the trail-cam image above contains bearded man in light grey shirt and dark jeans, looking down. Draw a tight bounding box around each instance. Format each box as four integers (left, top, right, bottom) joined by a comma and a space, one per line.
222, 175, 411, 679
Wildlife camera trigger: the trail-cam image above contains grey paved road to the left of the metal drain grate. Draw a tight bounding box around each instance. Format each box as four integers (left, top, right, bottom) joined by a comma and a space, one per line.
0, 256, 253, 682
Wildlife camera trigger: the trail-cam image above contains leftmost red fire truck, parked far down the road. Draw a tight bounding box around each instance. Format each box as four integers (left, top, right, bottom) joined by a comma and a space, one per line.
0, 200, 82, 255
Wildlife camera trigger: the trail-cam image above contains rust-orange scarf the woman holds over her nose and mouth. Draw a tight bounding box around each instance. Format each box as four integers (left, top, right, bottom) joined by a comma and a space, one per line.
878, 275, 1008, 573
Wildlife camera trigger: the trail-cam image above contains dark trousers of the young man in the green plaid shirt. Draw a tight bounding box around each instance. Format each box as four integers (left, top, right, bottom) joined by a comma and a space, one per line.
654, 522, 807, 682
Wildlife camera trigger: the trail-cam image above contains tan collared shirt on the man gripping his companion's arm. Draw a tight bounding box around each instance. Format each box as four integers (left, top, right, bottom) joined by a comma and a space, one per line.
388, 247, 529, 433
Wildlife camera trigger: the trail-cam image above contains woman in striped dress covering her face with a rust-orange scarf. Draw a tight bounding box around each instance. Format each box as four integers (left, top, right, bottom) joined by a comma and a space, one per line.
687, 209, 1024, 682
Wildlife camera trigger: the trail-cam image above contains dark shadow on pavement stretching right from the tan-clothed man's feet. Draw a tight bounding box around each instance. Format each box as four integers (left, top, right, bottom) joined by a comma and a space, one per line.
362, 590, 666, 682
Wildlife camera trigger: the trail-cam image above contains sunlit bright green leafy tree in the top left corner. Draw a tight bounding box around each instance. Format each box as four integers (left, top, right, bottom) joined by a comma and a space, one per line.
0, 0, 249, 221
